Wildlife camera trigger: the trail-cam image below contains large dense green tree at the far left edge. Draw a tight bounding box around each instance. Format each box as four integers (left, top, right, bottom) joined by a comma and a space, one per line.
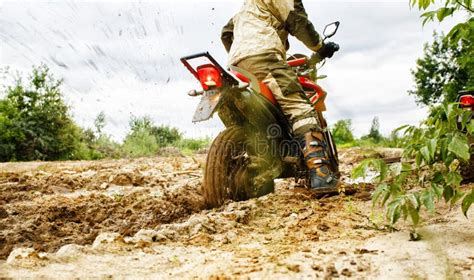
0, 65, 82, 161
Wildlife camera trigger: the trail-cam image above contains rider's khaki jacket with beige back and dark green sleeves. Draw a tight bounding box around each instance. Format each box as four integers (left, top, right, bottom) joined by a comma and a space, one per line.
221, 0, 321, 65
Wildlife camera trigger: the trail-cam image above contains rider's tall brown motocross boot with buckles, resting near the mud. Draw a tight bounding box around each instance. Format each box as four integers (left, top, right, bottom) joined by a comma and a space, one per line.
300, 131, 338, 194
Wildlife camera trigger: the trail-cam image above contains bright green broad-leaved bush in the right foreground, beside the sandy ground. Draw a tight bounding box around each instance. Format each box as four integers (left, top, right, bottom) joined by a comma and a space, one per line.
353, 103, 474, 236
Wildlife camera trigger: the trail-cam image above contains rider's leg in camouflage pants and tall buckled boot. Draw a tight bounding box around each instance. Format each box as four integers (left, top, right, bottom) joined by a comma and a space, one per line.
237, 54, 337, 193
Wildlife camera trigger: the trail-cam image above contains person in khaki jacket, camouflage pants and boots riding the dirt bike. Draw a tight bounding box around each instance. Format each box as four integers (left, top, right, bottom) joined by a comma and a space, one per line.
221, 0, 338, 193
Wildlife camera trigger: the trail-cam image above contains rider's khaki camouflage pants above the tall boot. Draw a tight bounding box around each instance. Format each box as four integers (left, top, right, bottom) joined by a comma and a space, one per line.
236, 54, 320, 136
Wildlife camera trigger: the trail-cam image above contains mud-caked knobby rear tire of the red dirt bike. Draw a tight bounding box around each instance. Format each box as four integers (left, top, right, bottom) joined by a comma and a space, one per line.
203, 126, 274, 208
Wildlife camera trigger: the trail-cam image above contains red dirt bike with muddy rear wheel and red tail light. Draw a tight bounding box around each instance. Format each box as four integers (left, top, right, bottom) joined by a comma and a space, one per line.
181, 22, 339, 208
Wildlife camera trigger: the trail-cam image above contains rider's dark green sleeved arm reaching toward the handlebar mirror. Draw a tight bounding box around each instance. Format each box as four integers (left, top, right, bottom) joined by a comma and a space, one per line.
286, 0, 322, 51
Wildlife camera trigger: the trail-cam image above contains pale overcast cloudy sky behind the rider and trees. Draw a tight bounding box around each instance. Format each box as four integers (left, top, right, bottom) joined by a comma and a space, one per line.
0, 0, 462, 139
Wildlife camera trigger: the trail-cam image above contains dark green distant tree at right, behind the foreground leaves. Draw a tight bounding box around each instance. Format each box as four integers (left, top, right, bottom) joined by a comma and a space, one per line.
409, 32, 473, 106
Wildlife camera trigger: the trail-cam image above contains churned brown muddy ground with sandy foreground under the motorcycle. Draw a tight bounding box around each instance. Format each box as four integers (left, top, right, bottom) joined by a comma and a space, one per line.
0, 149, 474, 279
